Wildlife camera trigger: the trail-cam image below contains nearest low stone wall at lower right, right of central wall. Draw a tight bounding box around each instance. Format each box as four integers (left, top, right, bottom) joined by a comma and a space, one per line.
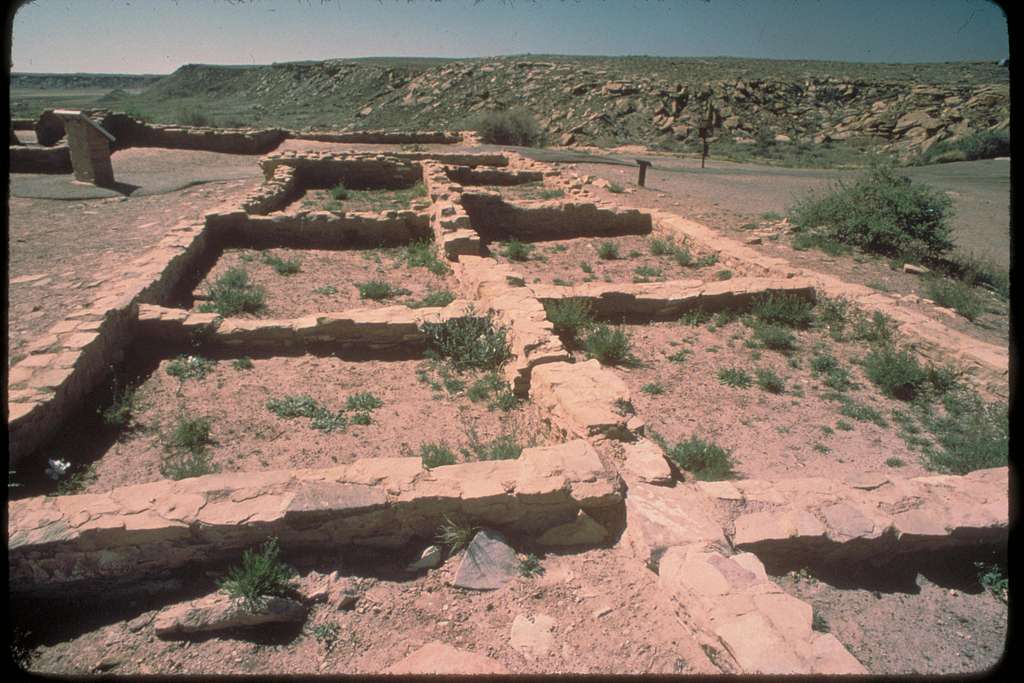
720, 467, 1010, 572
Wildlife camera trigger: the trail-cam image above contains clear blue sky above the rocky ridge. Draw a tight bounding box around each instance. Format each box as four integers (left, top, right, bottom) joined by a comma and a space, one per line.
11, 0, 1009, 74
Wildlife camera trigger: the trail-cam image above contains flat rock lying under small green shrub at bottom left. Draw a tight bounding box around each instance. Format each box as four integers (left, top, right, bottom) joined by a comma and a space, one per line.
153, 593, 306, 638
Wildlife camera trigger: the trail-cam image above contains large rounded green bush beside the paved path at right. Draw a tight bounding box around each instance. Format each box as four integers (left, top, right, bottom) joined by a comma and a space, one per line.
791, 165, 953, 256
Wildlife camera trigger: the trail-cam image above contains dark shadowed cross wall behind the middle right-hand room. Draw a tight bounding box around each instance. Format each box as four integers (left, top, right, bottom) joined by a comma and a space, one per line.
461, 190, 652, 242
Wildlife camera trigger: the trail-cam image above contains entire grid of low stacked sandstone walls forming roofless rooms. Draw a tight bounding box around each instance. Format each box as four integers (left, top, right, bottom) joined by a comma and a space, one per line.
8, 145, 1009, 674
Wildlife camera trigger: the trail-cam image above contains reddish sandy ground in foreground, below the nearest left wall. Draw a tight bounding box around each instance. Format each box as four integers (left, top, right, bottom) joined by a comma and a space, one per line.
16, 548, 717, 675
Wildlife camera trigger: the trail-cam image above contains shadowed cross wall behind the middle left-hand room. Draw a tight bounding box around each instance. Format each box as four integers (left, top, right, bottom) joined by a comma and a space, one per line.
212, 211, 430, 249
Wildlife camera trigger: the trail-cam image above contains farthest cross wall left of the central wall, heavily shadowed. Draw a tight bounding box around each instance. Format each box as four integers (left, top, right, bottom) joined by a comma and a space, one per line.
259, 150, 423, 189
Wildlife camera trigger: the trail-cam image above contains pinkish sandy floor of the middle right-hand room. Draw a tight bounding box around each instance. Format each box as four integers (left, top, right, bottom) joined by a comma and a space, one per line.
488, 232, 741, 285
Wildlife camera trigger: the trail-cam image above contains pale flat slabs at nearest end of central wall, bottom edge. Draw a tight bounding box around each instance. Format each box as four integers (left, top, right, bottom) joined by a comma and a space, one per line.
658, 543, 867, 674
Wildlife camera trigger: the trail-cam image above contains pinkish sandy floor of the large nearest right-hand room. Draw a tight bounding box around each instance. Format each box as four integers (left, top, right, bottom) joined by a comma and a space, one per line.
577, 322, 927, 478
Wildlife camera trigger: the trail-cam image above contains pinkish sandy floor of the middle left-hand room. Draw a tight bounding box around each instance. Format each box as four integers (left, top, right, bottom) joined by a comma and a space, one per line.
194, 249, 457, 318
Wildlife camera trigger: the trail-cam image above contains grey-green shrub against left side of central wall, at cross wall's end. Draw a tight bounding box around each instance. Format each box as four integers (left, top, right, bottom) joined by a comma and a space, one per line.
421, 311, 511, 370
